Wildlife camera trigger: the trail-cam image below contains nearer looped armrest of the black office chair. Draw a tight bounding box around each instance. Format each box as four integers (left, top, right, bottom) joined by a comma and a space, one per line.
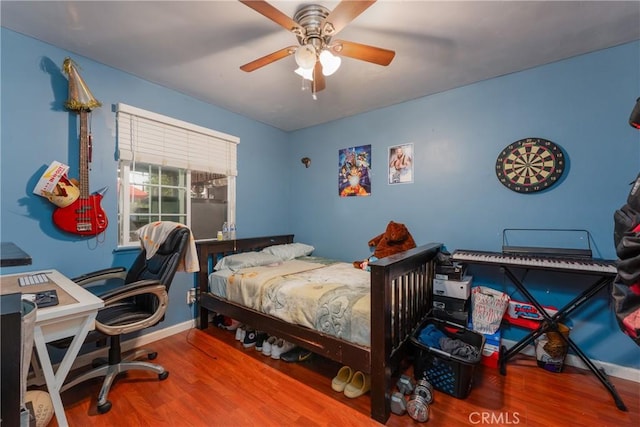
96, 280, 169, 335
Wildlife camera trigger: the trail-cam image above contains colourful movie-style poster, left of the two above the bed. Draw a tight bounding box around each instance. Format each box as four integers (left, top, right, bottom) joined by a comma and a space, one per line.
338, 145, 371, 197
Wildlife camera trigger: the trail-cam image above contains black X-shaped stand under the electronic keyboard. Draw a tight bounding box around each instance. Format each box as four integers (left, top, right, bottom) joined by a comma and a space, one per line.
498, 265, 627, 411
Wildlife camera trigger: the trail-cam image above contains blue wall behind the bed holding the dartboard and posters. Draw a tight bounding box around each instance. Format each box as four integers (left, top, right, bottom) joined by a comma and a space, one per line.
289, 42, 640, 368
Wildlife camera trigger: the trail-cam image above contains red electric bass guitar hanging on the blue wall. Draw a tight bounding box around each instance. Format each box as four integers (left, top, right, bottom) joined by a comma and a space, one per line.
53, 109, 109, 236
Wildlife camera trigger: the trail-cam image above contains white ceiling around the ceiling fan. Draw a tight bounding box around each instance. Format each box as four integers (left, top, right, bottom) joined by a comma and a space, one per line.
0, 0, 640, 131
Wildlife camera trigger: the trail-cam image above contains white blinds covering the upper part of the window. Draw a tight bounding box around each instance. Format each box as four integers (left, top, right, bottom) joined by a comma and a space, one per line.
116, 104, 240, 176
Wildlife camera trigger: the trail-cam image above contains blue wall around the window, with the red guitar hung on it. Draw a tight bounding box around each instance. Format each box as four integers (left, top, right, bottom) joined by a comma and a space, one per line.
0, 28, 292, 327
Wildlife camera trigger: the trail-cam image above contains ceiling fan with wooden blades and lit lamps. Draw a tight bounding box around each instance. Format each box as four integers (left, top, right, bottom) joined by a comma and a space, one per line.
239, 0, 396, 98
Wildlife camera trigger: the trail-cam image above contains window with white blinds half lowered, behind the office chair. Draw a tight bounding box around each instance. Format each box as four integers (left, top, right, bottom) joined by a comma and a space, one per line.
117, 104, 239, 246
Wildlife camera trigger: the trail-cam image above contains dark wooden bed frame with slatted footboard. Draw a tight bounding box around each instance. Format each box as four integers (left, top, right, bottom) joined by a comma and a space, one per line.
196, 234, 442, 424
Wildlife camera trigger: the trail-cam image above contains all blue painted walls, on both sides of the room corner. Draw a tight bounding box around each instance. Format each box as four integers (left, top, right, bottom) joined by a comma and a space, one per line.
0, 28, 640, 368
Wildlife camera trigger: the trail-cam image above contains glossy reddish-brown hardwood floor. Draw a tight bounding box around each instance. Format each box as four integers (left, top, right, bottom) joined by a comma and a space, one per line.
55, 326, 640, 427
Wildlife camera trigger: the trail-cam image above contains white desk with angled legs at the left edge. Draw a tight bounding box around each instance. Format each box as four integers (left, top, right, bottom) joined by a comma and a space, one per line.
0, 270, 104, 427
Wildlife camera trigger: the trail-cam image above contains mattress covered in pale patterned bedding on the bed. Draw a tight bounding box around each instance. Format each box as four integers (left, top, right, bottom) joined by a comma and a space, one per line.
209, 257, 371, 347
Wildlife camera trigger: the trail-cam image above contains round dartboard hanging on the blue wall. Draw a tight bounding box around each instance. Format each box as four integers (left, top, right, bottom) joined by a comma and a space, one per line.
496, 138, 564, 193
